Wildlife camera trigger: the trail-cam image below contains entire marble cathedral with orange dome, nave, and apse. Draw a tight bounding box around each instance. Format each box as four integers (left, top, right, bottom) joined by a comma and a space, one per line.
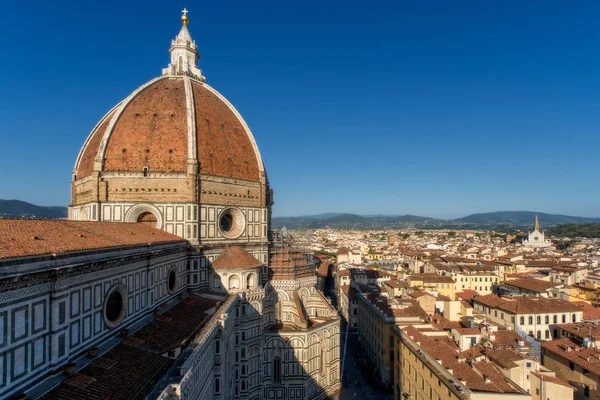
0, 10, 340, 400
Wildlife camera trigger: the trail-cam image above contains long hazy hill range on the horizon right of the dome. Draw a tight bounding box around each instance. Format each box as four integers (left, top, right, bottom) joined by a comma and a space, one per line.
272, 211, 600, 231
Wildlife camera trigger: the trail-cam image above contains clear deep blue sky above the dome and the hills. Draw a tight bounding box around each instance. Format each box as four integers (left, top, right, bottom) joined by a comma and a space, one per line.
0, 0, 600, 217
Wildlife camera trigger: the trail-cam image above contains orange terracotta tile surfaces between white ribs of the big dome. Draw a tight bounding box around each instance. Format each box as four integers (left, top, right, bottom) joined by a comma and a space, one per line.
77, 77, 261, 181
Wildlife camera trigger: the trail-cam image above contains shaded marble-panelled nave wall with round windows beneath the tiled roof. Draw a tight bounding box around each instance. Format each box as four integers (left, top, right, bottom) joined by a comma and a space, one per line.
0, 245, 187, 398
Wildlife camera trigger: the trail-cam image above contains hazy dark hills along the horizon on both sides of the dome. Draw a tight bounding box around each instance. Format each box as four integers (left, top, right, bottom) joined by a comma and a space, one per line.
0, 200, 600, 231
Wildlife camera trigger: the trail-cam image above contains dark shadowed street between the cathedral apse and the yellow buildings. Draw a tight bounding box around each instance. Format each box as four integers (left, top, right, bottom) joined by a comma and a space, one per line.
326, 280, 394, 400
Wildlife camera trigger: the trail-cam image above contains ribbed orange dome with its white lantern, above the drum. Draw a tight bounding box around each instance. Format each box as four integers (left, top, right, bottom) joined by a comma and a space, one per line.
73, 10, 264, 181
